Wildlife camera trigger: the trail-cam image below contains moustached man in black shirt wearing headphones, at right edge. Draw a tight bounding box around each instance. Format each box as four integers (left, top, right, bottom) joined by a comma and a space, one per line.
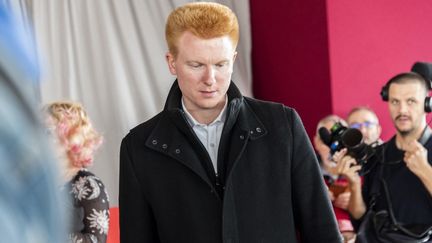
333, 72, 432, 242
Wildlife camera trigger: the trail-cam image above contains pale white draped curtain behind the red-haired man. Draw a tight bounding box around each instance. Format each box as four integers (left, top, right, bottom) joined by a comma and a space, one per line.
27, 0, 252, 206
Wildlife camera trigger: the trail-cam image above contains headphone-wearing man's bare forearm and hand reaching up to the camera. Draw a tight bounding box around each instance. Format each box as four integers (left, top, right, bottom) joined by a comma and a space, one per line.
333, 149, 366, 219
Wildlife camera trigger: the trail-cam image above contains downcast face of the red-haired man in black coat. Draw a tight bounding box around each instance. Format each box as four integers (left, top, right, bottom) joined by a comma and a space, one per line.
167, 31, 237, 112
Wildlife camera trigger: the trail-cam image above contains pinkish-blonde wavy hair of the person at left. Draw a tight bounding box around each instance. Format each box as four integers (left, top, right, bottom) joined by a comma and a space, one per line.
44, 101, 102, 168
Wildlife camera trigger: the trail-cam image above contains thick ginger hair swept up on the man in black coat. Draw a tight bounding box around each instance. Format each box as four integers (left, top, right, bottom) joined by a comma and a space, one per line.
165, 2, 239, 57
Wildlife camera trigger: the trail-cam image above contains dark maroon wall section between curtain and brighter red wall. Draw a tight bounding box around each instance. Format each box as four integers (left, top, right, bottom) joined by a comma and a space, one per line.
250, 0, 332, 138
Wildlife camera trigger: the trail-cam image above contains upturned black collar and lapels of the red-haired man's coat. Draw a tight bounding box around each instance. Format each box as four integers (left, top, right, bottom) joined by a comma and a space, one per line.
146, 81, 267, 191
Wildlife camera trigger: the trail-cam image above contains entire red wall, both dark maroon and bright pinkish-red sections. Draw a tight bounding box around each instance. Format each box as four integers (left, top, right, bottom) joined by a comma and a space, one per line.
250, 0, 432, 139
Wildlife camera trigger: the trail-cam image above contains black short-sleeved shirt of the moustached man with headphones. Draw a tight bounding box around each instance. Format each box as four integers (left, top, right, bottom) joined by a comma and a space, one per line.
363, 137, 432, 225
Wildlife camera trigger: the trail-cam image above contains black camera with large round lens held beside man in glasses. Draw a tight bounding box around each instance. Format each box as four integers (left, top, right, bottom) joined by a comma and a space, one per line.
318, 122, 375, 165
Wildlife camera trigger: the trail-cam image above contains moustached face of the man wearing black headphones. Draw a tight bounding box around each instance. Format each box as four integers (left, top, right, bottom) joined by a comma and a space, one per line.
388, 82, 426, 136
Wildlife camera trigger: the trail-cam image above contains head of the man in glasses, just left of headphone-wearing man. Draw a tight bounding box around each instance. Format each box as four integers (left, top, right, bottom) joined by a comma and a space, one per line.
347, 109, 381, 144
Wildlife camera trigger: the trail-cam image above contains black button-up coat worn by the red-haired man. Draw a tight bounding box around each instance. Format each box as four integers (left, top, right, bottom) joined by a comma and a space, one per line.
119, 82, 341, 243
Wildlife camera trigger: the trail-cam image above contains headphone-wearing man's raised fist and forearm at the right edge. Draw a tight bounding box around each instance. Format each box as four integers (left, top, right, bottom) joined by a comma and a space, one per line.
403, 140, 432, 196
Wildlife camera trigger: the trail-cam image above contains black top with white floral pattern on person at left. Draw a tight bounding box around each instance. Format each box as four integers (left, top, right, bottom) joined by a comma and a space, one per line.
65, 169, 109, 243
